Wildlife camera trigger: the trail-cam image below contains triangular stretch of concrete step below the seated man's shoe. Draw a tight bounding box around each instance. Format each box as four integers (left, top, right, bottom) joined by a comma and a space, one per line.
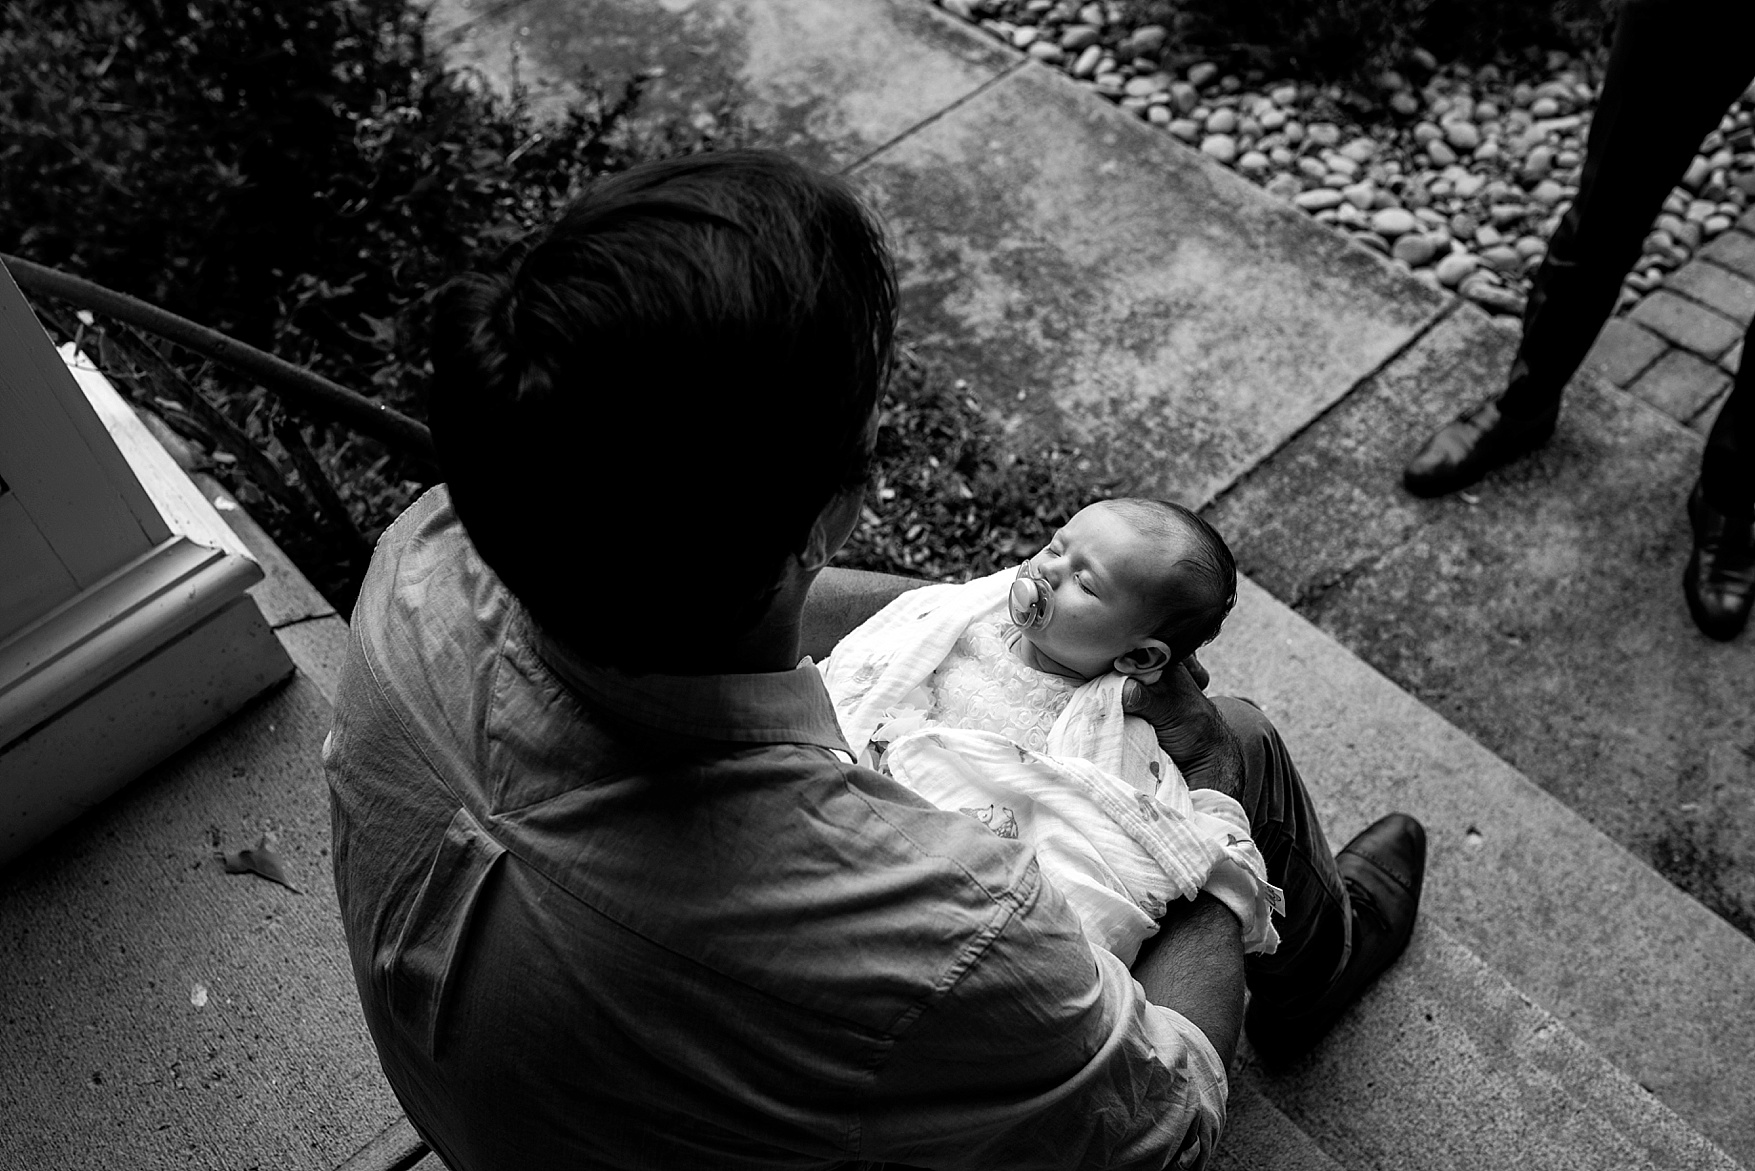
1239, 922, 1737, 1171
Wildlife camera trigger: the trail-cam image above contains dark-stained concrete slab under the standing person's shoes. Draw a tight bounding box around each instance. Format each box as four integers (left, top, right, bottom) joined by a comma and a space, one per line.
1211, 301, 1755, 905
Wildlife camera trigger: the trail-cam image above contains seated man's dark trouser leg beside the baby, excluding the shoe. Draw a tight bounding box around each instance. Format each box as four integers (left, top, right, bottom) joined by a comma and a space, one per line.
1213, 695, 1351, 1013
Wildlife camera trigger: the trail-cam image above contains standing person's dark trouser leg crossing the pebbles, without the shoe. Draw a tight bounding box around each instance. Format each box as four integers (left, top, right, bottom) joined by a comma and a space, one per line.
1501, 0, 1755, 419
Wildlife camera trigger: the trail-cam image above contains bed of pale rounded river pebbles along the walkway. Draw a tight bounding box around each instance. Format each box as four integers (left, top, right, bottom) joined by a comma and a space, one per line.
935, 0, 1755, 314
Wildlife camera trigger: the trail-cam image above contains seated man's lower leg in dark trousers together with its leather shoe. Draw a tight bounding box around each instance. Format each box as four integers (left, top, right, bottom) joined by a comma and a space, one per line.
1213, 695, 1425, 1060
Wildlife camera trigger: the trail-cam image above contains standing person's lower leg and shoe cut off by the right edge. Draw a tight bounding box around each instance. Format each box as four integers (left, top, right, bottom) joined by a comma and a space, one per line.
1681, 323, 1755, 639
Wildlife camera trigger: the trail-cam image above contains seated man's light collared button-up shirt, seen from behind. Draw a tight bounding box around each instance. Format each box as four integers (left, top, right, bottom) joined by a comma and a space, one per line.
325, 488, 1225, 1171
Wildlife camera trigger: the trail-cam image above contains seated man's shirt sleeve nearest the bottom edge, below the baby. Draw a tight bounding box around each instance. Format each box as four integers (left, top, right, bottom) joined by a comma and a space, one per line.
860, 860, 1229, 1171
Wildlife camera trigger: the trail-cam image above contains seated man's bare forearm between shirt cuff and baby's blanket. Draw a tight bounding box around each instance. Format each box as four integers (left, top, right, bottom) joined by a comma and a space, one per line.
1134, 888, 1243, 1067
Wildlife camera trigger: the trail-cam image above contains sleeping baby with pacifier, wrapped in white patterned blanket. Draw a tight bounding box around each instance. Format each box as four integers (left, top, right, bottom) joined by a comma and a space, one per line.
823, 499, 1279, 960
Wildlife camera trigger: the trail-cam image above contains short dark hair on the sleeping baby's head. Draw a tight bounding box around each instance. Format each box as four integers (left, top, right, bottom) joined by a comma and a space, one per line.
1104, 497, 1237, 662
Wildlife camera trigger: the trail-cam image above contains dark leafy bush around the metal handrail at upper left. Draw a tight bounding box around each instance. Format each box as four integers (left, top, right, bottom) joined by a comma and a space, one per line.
0, 0, 735, 607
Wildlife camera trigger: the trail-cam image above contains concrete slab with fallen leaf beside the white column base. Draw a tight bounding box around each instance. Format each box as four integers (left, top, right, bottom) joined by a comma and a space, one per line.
0, 676, 387, 1171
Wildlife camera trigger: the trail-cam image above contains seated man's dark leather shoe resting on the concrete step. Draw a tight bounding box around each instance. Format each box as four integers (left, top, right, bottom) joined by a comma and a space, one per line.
1244, 813, 1425, 1066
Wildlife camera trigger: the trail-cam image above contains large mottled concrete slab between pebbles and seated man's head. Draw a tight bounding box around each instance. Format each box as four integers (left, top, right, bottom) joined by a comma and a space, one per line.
855, 63, 1446, 504
